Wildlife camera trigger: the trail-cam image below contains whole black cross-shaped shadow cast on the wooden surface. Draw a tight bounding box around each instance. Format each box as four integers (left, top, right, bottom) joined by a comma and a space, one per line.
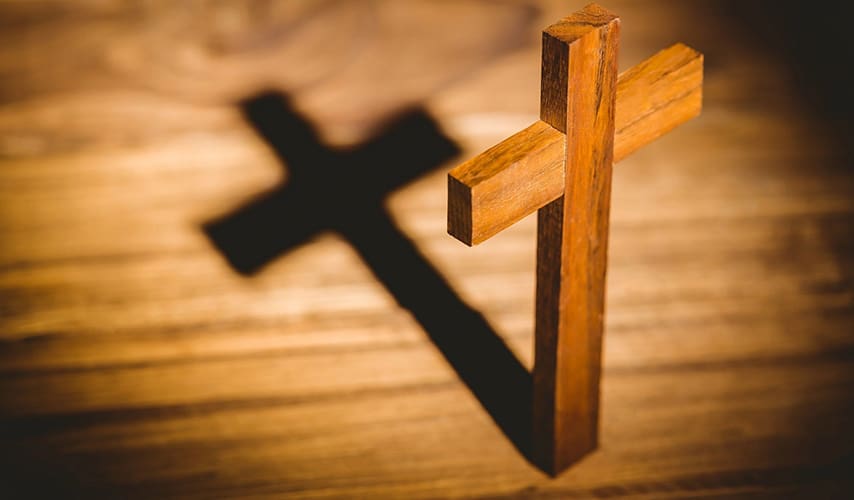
204, 93, 533, 463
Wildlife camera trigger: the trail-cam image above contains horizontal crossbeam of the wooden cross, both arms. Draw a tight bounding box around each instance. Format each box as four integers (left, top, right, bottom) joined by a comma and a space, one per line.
448, 43, 703, 245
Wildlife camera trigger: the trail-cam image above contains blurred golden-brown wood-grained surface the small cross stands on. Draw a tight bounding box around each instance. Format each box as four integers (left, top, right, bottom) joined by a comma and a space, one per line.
0, 0, 854, 498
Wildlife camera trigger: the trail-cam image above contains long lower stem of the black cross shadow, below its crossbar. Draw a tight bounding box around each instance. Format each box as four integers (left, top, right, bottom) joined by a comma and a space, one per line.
342, 208, 533, 463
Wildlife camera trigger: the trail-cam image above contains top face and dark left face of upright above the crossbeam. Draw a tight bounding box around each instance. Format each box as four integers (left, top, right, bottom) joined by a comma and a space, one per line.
540, 3, 620, 133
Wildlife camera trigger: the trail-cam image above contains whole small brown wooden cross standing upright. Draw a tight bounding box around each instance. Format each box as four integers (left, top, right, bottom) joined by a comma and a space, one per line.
448, 4, 703, 474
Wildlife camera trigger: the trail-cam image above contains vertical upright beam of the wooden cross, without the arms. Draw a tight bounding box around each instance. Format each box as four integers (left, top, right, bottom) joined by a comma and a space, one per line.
533, 4, 620, 475
